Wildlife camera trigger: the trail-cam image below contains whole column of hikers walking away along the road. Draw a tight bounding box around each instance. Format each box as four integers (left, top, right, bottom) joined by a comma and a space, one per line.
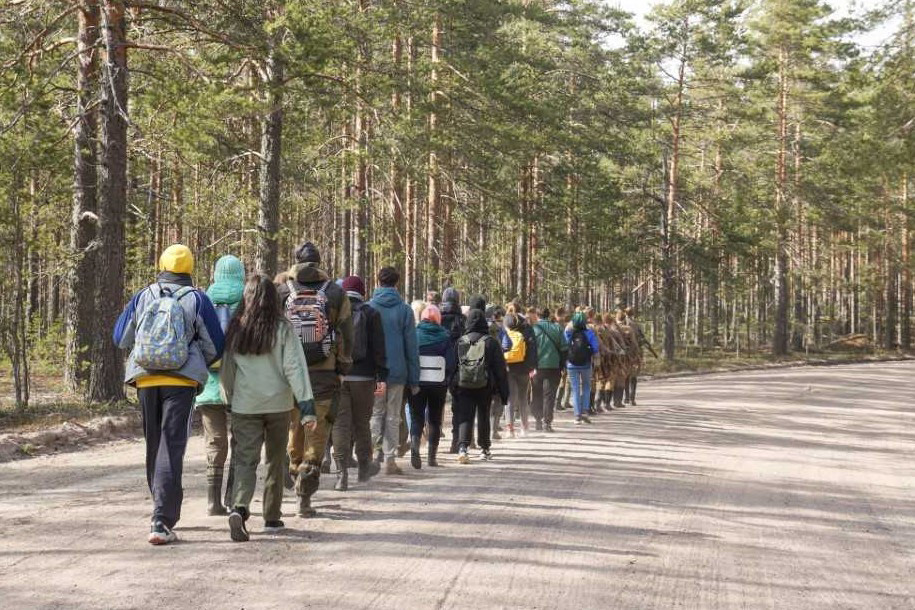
114, 242, 650, 545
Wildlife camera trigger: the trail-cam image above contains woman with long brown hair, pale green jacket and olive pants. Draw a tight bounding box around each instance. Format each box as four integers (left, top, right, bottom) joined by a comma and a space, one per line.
221, 275, 317, 542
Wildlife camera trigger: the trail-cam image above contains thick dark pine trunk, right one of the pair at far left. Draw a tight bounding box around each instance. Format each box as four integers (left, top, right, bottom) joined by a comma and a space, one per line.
89, 0, 128, 402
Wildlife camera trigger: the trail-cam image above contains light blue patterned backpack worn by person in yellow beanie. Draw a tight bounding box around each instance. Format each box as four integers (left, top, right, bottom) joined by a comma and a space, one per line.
133, 284, 194, 371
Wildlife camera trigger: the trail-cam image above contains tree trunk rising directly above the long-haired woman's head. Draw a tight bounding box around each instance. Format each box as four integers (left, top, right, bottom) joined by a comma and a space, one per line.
255, 46, 284, 277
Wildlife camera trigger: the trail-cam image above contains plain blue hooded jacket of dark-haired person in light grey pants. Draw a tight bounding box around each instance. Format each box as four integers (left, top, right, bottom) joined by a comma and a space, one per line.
369, 287, 419, 385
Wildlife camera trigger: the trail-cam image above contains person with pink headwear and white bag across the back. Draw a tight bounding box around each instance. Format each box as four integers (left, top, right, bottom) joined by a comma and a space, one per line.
410, 304, 457, 470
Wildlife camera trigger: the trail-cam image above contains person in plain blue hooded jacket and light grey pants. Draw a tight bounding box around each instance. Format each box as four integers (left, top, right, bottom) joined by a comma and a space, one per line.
369, 267, 419, 474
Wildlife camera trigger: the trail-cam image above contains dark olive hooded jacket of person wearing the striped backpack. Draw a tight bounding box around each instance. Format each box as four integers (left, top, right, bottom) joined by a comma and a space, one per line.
277, 263, 353, 378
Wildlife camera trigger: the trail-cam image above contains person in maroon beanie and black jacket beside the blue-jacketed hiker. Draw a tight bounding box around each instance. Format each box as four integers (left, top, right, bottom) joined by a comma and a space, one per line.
333, 275, 388, 491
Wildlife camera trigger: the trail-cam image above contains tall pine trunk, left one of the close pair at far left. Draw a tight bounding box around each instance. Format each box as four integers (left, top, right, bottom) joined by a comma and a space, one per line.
64, 0, 99, 391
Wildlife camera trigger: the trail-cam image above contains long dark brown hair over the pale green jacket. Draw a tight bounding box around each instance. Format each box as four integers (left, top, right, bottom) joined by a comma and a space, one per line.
226, 274, 283, 355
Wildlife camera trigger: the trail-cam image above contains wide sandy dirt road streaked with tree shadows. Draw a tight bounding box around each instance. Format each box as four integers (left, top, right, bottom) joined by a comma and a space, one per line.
0, 363, 915, 610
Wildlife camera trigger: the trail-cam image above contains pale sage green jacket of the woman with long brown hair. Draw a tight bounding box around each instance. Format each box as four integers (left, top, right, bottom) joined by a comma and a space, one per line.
220, 320, 315, 421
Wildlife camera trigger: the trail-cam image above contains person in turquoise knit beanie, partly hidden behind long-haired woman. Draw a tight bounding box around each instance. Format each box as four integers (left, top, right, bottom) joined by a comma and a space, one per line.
194, 254, 245, 517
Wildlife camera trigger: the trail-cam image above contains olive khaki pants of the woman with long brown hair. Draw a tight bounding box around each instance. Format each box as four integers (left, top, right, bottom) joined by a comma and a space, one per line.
232, 412, 289, 521
